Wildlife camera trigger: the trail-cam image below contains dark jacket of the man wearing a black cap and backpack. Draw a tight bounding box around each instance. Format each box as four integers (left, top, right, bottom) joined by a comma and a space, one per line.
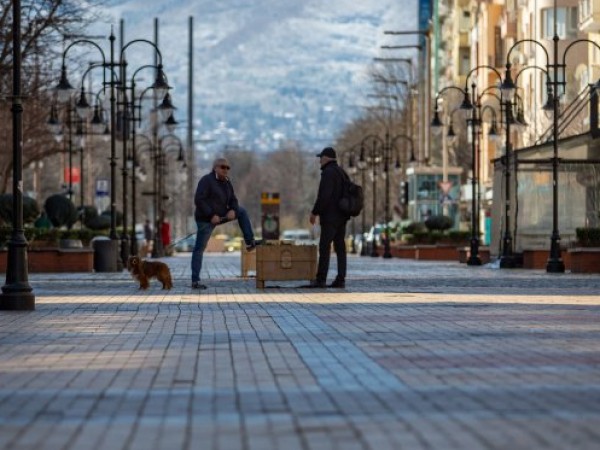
312, 161, 349, 223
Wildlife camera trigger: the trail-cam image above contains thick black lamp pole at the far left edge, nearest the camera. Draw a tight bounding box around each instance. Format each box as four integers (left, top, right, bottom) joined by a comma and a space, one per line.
0, 0, 35, 311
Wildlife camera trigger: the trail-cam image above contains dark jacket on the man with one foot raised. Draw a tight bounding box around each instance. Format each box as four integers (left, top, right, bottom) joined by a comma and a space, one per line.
194, 170, 239, 222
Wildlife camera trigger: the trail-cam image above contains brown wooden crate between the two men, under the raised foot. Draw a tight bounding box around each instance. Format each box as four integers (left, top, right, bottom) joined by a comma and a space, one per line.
255, 243, 317, 289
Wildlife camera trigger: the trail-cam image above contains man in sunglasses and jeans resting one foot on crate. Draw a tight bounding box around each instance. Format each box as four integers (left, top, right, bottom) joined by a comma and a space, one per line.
192, 158, 256, 289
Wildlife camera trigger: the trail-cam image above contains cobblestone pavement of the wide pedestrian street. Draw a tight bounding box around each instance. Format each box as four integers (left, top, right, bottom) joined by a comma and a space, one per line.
0, 254, 600, 450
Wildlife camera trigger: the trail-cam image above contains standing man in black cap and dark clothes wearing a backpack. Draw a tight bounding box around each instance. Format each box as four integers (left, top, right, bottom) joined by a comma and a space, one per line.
305, 147, 349, 288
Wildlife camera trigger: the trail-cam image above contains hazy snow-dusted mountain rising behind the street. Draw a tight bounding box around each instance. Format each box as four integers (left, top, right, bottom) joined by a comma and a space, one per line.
97, 0, 417, 151
